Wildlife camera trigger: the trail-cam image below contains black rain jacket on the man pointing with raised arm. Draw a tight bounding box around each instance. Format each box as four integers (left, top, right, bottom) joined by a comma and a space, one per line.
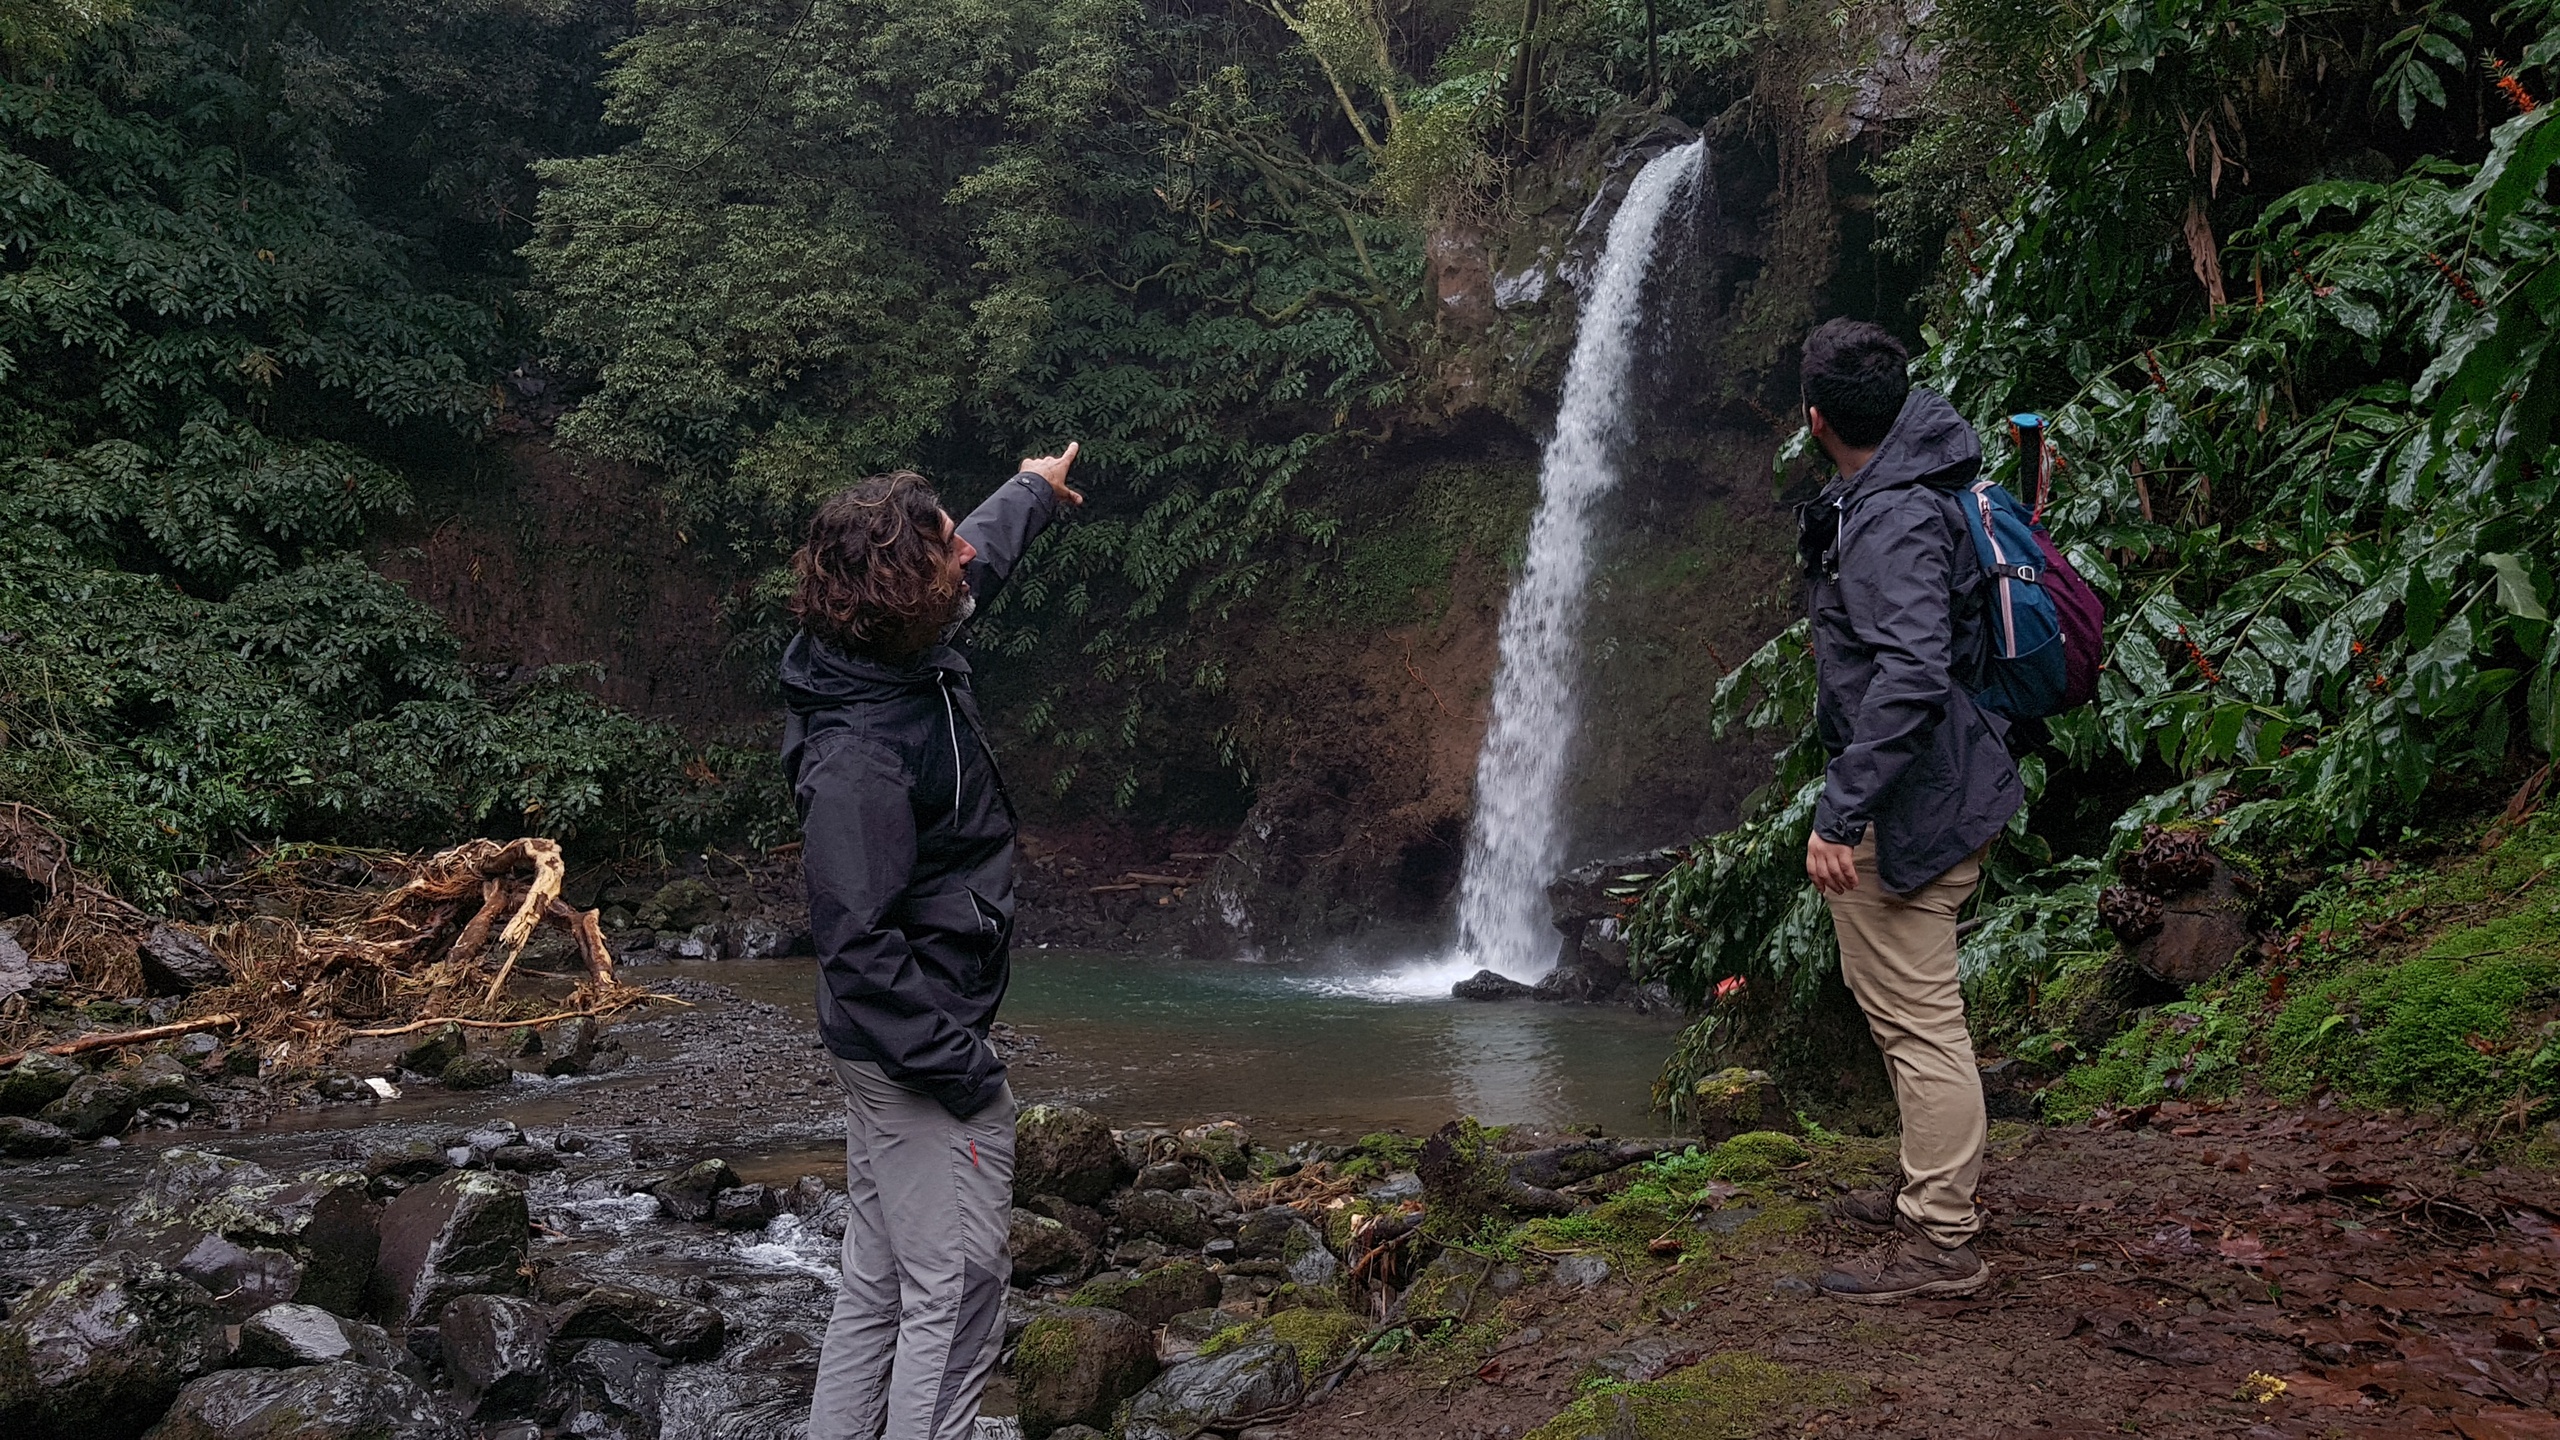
781, 474, 1057, 1117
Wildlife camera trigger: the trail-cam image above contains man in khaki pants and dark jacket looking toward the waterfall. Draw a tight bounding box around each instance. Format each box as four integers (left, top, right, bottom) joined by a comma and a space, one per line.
1797, 320, 2022, 1302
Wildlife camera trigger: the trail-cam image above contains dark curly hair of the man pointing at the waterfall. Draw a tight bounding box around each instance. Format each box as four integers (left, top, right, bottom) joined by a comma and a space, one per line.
791, 469, 960, 659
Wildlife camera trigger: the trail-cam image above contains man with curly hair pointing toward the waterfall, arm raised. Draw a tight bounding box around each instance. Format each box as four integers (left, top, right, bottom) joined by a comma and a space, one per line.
781, 446, 1083, 1440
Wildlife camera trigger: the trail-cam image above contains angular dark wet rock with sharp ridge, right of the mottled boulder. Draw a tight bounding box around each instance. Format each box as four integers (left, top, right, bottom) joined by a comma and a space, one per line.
366, 1171, 530, 1325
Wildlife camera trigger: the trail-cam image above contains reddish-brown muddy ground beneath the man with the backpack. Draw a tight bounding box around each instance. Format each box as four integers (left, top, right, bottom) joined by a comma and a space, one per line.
1300, 1102, 2560, 1440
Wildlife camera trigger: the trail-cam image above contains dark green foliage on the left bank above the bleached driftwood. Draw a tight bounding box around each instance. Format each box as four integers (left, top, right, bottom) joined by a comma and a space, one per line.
0, 0, 757, 892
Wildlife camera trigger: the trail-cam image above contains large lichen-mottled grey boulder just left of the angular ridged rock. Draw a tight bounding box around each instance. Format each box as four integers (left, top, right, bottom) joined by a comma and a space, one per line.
118, 1148, 381, 1314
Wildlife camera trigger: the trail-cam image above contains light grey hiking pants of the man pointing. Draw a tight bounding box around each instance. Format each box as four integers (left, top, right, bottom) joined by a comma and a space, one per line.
809, 1061, 1014, 1440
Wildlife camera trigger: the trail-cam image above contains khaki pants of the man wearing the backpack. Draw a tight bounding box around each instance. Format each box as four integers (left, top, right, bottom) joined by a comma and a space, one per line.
1830, 825, 1984, 1248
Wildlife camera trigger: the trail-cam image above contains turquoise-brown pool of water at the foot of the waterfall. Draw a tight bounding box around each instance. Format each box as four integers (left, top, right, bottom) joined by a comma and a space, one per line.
691, 951, 1679, 1138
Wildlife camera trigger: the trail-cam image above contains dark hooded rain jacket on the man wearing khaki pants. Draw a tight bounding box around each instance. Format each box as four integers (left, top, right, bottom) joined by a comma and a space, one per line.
1812, 389, 2025, 894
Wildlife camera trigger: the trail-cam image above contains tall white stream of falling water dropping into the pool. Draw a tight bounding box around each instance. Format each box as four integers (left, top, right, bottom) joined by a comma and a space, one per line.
1449, 141, 1705, 979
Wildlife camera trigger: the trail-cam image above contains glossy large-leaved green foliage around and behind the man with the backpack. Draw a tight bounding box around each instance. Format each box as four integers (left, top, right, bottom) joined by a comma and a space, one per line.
1636, 0, 2560, 1122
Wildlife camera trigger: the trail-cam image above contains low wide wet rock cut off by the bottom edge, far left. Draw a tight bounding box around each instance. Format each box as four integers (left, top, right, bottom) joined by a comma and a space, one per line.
148, 1363, 466, 1440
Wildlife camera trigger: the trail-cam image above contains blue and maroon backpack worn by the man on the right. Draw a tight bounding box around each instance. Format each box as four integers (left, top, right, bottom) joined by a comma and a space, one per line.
1956, 415, 2107, 720
